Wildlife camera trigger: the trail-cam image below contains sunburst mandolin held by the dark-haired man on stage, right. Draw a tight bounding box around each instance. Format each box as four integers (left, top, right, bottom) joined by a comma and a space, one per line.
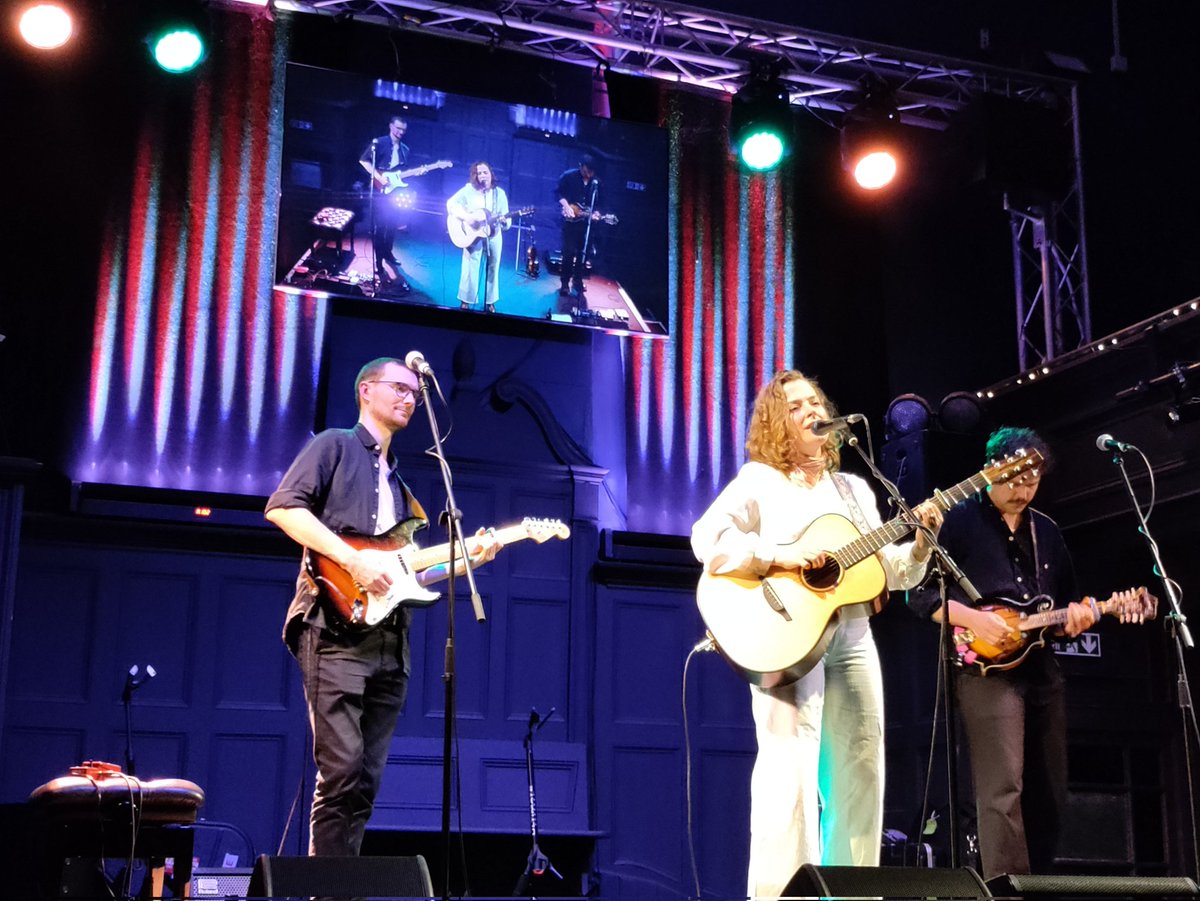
954, 587, 1158, 675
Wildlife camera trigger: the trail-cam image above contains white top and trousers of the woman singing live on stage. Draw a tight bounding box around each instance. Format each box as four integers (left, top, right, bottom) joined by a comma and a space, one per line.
691, 463, 925, 899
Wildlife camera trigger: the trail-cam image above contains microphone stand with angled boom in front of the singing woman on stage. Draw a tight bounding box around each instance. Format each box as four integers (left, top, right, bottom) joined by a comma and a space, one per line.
846, 434, 980, 869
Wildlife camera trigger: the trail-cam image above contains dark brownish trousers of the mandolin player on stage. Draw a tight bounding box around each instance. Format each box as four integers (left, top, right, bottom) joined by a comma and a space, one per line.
955, 649, 1067, 878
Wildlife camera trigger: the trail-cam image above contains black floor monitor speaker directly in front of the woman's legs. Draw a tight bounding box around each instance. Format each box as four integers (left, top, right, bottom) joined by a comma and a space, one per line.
784, 864, 991, 899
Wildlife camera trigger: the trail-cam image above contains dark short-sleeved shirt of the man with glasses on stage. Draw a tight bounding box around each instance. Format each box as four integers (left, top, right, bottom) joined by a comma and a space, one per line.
266, 422, 425, 654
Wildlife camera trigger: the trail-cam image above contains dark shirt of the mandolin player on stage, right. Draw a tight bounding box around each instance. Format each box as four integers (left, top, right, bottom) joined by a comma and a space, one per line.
908, 494, 1079, 617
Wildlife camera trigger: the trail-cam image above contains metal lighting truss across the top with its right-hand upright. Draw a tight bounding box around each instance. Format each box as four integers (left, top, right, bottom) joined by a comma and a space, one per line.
260, 0, 1091, 370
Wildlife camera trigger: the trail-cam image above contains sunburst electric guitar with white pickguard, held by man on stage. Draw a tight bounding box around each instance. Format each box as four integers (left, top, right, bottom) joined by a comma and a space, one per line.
304, 517, 571, 631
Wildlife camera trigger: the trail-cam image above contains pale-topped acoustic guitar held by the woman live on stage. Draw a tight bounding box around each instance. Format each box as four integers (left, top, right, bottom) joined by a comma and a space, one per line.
696, 450, 1042, 687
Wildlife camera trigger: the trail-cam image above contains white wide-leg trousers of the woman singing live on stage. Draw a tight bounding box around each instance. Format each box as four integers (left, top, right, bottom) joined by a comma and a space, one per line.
749, 618, 883, 899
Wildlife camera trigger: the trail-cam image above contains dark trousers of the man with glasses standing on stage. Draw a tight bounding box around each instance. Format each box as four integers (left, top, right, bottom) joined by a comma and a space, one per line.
298, 626, 409, 857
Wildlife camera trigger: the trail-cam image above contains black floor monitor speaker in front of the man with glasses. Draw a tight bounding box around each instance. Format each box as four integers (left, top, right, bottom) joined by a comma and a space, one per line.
247, 854, 433, 899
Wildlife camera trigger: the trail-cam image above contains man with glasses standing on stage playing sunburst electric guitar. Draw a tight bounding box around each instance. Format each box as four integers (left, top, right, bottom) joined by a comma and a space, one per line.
266, 358, 499, 857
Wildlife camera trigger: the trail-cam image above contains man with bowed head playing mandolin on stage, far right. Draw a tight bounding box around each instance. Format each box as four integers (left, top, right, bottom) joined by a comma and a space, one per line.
910, 426, 1108, 879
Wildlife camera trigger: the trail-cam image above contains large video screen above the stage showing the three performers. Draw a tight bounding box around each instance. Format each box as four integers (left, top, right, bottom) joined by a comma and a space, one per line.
276, 64, 668, 336
